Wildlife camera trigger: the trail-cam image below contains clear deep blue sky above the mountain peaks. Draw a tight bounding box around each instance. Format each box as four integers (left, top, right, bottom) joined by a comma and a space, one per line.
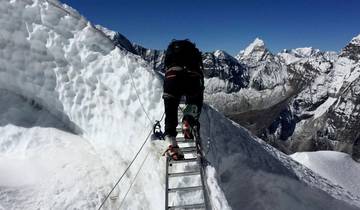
60, 0, 360, 55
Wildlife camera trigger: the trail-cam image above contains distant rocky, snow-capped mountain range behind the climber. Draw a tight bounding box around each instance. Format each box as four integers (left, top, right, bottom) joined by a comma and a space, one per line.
97, 26, 360, 159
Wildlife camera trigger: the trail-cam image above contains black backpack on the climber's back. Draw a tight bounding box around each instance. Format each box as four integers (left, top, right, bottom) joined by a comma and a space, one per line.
165, 39, 203, 72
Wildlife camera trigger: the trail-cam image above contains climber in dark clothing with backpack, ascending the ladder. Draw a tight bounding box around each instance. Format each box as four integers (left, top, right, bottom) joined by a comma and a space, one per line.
163, 39, 204, 160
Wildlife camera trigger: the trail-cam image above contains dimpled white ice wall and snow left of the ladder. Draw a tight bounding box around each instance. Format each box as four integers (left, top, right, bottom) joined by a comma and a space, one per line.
0, 0, 163, 209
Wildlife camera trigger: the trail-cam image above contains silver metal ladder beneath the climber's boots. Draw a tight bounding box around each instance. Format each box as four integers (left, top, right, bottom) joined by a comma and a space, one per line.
165, 106, 209, 210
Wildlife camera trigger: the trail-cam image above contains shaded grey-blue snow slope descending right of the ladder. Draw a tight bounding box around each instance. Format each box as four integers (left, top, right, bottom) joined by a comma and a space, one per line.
202, 107, 360, 210
